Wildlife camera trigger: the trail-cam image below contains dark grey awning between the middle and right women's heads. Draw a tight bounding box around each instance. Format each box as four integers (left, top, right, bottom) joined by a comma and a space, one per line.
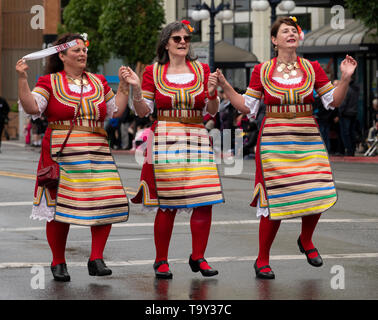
192, 40, 259, 68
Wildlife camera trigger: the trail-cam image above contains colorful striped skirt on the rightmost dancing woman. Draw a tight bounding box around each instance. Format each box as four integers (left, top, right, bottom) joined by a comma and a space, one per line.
251, 116, 337, 220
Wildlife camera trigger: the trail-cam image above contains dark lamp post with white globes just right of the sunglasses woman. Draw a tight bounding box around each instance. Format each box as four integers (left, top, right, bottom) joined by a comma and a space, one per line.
192, 0, 233, 72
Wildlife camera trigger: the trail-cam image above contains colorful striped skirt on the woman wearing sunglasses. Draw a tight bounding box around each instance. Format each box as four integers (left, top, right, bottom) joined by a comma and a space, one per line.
132, 121, 224, 209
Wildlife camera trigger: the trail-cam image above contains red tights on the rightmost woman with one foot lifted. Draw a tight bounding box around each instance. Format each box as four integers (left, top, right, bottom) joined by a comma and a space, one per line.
257, 214, 320, 272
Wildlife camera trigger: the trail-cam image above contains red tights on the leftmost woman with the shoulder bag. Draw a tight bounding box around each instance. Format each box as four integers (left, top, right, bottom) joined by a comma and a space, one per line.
46, 221, 112, 266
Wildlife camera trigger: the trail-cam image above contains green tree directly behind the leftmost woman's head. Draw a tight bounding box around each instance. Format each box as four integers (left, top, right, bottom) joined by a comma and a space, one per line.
59, 0, 112, 72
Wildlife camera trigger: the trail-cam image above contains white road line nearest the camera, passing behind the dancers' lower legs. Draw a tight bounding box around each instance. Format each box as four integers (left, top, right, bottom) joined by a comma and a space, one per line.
0, 252, 378, 269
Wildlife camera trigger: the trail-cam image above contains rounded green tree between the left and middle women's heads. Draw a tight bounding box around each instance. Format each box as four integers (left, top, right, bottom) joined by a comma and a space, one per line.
99, 0, 165, 73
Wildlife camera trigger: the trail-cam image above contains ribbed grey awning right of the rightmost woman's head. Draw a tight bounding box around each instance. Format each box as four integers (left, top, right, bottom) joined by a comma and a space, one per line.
298, 19, 378, 53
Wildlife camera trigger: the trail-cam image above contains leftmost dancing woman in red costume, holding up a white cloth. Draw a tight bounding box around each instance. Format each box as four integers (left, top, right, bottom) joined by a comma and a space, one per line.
16, 34, 129, 281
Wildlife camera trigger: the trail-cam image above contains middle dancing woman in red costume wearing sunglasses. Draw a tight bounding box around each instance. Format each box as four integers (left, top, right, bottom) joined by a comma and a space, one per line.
126, 20, 224, 279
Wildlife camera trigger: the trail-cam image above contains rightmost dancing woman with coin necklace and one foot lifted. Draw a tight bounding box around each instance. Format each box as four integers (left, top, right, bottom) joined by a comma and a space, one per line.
217, 17, 357, 279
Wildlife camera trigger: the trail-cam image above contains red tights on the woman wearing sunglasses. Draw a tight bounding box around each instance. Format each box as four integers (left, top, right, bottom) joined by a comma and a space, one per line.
154, 206, 212, 272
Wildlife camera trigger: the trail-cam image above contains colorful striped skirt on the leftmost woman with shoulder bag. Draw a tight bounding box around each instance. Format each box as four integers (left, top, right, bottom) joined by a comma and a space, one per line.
45, 130, 129, 226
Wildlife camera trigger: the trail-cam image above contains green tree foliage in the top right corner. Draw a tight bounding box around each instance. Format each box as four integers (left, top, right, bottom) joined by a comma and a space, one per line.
345, 0, 378, 37
